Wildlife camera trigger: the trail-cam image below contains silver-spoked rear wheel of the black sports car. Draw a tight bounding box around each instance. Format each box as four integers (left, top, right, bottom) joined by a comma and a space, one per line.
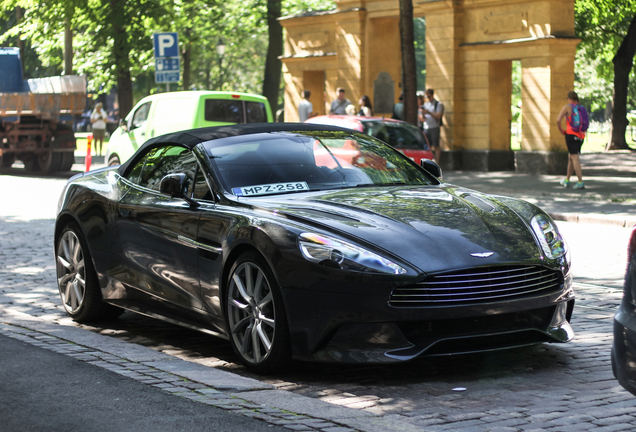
55, 223, 123, 322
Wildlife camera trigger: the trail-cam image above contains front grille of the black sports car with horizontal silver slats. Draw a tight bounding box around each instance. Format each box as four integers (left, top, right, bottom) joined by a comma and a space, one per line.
389, 266, 563, 307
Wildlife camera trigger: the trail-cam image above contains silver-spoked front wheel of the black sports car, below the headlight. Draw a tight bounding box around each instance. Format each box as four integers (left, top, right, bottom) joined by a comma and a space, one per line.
225, 252, 291, 373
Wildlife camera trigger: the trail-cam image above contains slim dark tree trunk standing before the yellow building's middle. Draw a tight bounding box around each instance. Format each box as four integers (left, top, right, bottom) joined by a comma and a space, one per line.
400, 0, 417, 126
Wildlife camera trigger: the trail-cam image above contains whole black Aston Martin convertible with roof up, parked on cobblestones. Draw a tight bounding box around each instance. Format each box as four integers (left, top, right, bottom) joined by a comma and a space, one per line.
55, 123, 574, 372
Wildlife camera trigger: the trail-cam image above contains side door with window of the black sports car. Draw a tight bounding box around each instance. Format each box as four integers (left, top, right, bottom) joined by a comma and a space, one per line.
117, 145, 203, 316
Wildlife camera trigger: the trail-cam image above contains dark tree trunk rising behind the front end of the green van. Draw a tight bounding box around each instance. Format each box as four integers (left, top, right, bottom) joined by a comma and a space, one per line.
109, 0, 133, 118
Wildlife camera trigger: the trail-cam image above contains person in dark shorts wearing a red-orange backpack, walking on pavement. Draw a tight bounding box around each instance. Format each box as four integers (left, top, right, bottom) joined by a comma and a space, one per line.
557, 91, 590, 189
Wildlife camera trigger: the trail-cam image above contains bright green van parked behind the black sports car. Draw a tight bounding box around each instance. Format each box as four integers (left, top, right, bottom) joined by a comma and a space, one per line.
105, 91, 274, 165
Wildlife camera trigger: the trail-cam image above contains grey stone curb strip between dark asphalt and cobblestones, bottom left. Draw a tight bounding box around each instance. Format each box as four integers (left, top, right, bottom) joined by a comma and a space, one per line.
0, 308, 422, 432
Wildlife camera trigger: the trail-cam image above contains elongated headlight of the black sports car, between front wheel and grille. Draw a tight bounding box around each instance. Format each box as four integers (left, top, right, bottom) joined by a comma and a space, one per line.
298, 233, 406, 275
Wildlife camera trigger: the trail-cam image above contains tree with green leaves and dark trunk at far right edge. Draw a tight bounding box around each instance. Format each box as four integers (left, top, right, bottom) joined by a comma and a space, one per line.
575, 0, 636, 149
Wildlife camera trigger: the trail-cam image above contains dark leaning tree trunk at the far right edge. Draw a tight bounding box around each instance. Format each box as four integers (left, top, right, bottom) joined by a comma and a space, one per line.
608, 16, 636, 150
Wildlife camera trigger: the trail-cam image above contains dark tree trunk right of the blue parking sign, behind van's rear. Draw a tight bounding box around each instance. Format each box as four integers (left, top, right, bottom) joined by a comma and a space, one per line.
263, 0, 283, 116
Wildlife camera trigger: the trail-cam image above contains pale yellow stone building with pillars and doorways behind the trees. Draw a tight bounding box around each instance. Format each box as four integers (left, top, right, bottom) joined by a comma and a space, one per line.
281, 0, 579, 173
